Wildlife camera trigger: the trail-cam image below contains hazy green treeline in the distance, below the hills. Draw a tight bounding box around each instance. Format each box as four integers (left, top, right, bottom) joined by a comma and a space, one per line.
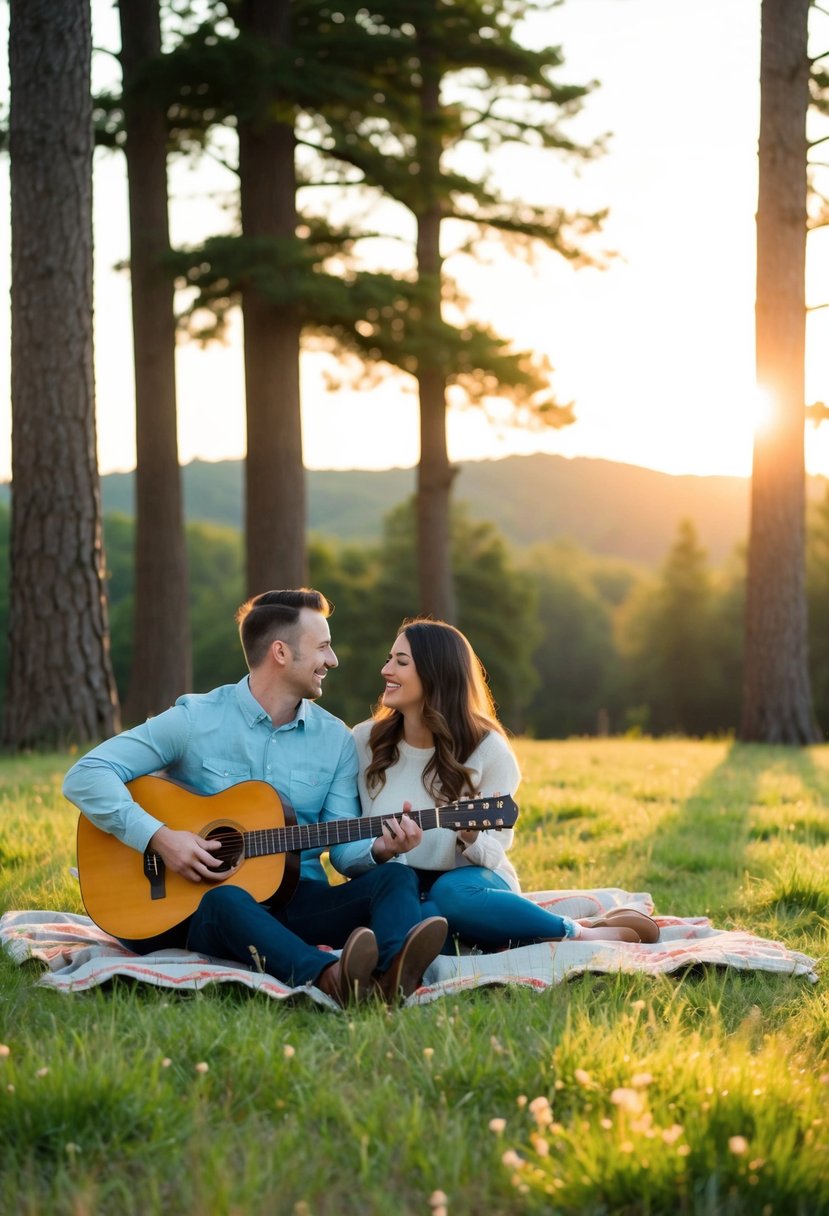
0, 495, 829, 738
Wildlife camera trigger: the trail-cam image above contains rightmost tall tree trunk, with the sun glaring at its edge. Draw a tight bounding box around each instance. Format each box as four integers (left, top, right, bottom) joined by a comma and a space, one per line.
740, 0, 819, 744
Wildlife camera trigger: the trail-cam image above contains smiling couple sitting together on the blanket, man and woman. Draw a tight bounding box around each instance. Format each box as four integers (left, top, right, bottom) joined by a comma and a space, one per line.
63, 589, 658, 1006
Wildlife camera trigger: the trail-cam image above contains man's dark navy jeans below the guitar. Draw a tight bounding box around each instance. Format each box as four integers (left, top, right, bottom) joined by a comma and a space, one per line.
123, 866, 423, 987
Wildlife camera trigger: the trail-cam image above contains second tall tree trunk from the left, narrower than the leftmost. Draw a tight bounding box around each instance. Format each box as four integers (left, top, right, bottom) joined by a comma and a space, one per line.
119, 0, 193, 722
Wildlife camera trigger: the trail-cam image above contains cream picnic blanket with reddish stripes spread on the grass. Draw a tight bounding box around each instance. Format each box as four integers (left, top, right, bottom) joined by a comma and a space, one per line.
0, 888, 817, 1009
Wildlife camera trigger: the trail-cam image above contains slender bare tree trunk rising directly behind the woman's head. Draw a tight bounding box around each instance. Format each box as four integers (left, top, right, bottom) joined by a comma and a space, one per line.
416, 35, 457, 624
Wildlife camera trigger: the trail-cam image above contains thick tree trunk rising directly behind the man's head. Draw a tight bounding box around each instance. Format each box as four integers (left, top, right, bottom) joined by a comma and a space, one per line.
238, 0, 308, 595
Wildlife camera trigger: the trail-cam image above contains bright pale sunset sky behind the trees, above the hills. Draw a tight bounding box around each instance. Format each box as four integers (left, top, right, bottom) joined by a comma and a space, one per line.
0, 0, 829, 480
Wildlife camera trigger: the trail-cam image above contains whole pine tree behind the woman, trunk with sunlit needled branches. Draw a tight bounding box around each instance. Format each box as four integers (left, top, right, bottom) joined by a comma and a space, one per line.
323, 0, 602, 620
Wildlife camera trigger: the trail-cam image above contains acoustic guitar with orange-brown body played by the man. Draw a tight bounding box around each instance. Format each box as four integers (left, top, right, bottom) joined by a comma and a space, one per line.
78, 777, 518, 939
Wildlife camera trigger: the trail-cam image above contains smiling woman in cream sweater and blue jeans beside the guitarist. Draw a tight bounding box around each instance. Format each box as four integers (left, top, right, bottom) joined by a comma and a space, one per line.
345, 618, 659, 951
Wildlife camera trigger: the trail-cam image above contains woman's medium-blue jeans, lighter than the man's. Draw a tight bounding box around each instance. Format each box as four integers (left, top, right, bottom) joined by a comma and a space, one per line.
421, 866, 576, 955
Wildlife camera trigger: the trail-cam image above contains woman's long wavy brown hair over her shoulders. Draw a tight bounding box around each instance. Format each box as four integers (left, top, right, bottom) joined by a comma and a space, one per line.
366, 617, 504, 803
